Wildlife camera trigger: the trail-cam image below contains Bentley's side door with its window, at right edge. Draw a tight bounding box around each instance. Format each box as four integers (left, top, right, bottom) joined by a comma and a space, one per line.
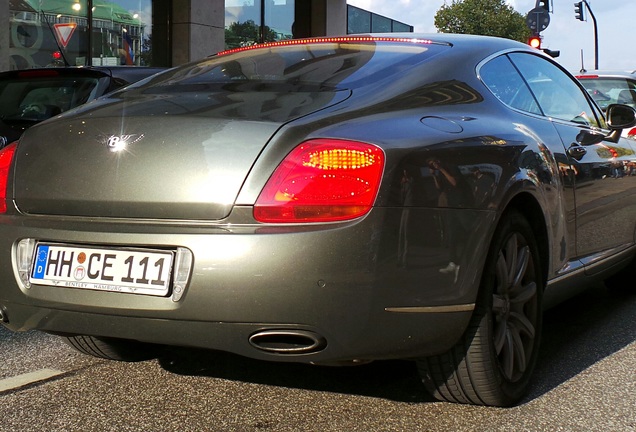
509, 53, 636, 271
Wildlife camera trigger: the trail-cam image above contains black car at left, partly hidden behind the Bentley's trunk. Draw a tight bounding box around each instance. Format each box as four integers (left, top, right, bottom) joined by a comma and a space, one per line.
0, 66, 165, 147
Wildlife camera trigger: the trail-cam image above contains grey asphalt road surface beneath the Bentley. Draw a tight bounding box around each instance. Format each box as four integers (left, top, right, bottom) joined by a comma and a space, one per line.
0, 286, 636, 432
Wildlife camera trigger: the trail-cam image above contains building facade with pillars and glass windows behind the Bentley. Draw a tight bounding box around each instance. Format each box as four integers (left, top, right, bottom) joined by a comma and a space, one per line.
0, 0, 413, 71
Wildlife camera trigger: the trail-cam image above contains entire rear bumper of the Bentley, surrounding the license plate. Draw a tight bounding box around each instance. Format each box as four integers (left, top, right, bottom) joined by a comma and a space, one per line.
0, 209, 492, 362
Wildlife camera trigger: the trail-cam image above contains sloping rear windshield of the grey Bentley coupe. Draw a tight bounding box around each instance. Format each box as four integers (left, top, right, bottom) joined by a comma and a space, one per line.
147, 42, 449, 91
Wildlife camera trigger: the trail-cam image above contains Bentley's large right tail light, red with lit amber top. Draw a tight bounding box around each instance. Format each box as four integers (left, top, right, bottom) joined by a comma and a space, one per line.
254, 139, 384, 223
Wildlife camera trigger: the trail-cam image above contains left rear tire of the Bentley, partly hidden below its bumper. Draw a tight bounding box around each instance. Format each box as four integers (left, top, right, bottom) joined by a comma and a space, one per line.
63, 336, 157, 362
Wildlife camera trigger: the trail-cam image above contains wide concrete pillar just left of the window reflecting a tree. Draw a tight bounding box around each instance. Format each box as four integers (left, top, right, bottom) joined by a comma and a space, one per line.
172, 0, 225, 66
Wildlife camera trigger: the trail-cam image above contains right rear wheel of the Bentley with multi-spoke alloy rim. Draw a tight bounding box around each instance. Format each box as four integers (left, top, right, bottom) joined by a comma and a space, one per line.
417, 211, 544, 406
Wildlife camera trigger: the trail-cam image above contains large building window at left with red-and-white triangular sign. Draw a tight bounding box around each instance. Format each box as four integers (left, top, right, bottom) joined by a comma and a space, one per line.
9, 0, 152, 69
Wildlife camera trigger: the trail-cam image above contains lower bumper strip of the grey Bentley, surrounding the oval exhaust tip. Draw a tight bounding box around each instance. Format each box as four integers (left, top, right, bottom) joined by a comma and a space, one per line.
0, 304, 471, 362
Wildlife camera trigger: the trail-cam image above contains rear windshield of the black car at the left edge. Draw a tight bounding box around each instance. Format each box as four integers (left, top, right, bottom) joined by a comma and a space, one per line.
0, 76, 99, 121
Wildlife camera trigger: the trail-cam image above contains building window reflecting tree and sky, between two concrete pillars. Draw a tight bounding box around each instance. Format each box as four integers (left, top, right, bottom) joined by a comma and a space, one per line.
225, 0, 295, 48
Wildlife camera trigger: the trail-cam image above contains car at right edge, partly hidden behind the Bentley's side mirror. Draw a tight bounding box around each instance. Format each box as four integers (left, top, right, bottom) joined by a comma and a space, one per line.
576, 71, 636, 139
